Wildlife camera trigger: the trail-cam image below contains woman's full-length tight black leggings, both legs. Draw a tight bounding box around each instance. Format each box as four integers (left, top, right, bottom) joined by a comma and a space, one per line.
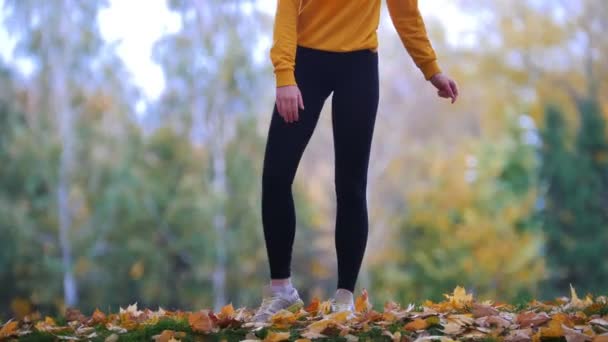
262, 46, 378, 291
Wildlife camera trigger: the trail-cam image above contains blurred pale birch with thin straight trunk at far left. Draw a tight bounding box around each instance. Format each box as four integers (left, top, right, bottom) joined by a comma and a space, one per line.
4, 0, 114, 305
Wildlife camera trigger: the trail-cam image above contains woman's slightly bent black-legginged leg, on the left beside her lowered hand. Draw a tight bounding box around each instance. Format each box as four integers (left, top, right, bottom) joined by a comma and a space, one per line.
262, 48, 331, 279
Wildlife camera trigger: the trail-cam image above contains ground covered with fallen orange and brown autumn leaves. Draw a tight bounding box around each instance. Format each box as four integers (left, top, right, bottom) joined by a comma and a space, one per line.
0, 287, 608, 342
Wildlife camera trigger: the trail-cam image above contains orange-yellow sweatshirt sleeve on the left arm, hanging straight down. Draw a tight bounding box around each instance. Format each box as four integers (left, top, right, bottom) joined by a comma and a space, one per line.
270, 0, 300, 87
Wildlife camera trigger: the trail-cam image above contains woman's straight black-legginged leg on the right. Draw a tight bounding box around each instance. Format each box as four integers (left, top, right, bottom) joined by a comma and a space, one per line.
332, 50, 378, 292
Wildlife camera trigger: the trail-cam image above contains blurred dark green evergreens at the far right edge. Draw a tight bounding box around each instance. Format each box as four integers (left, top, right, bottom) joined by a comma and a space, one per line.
541, 98, 608, 294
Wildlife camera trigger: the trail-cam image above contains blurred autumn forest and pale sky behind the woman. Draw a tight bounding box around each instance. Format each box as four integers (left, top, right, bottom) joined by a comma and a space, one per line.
0, 0, 608, 320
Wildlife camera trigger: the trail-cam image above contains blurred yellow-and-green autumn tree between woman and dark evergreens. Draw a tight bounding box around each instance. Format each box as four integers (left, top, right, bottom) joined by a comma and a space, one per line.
374, 116, 544, 308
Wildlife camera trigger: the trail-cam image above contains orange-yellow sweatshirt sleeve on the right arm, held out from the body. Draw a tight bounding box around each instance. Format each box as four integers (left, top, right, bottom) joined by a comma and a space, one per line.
386, 0, 441, 80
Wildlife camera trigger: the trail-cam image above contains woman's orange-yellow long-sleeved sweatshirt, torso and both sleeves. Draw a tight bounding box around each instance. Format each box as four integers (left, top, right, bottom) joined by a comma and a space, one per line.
270, 0, 441, 87
